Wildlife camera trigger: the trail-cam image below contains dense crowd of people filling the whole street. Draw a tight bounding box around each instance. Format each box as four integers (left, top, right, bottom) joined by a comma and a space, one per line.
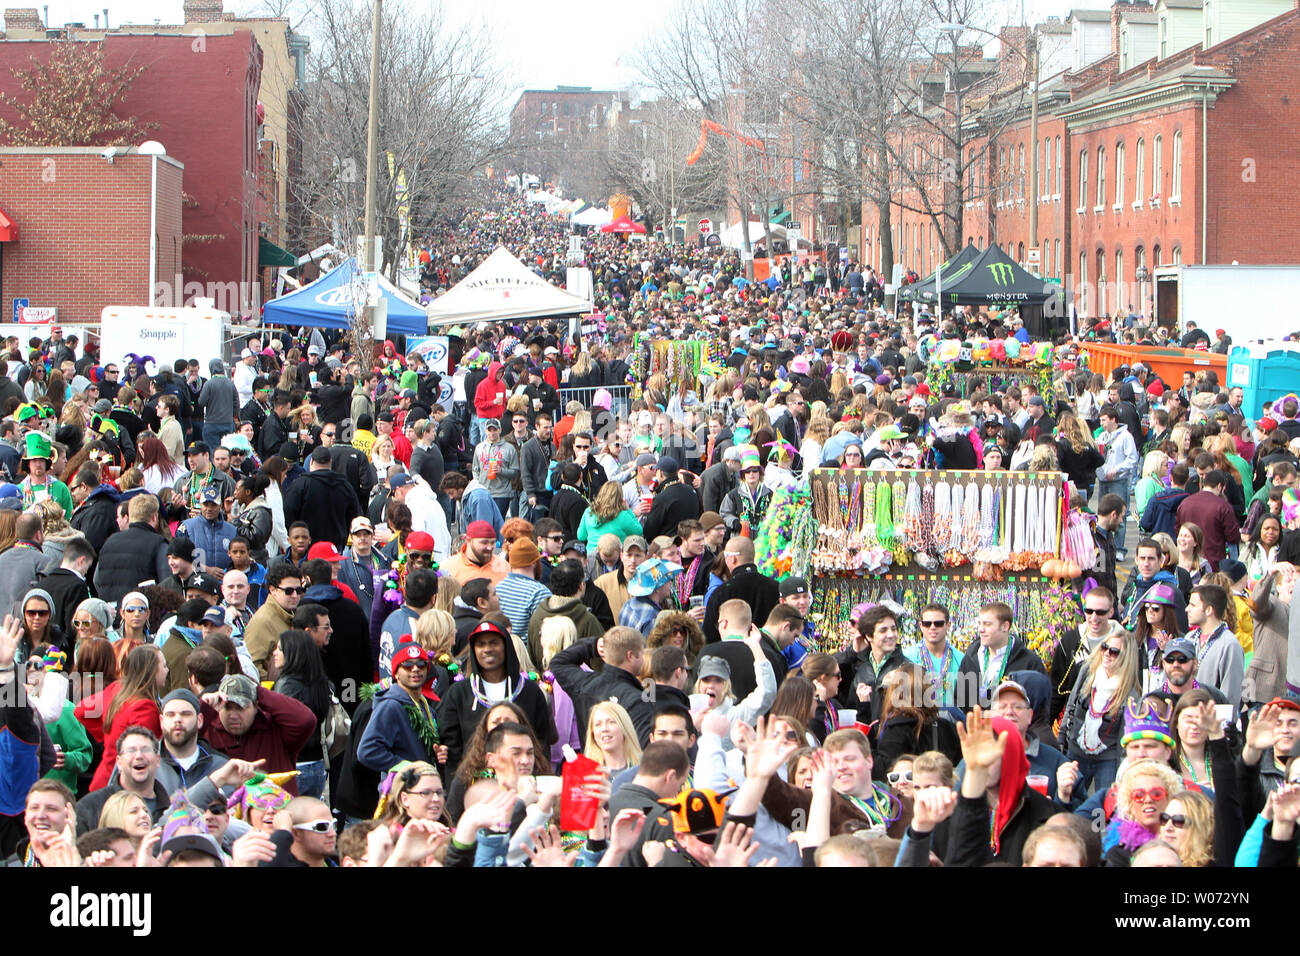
0, 174, 1300, 868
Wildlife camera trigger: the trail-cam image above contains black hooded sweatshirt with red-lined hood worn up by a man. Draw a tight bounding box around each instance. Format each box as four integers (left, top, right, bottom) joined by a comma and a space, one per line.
438, 624, 556, 780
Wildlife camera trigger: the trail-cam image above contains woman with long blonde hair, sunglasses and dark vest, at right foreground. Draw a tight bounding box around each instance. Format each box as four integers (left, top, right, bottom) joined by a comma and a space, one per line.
1061, 630, 1143, 792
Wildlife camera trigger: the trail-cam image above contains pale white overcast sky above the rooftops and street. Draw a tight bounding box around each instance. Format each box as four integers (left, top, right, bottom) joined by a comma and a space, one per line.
40, 0, 1092, 92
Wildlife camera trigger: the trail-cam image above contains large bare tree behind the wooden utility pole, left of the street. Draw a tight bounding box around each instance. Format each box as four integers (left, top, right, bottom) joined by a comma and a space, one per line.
296, 0, 508, 280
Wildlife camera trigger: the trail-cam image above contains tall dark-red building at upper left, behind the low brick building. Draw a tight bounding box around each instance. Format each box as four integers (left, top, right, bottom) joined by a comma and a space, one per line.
0, 19, 263, 311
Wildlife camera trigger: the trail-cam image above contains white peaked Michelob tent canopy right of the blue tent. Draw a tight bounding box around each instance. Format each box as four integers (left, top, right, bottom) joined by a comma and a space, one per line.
426, 246, 592, 328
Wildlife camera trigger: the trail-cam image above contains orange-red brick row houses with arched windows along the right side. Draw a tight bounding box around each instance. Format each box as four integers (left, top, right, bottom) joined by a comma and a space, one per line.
862, 0, 1300, 321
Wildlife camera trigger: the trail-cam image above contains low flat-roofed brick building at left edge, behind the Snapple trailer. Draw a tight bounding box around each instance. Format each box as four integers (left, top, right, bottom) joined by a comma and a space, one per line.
0, 146, 185, 323
